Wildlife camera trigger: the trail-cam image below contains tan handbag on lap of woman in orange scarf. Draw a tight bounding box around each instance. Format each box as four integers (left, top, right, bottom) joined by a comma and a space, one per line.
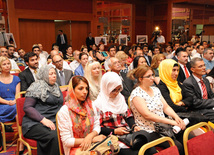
75, 135, 120, 155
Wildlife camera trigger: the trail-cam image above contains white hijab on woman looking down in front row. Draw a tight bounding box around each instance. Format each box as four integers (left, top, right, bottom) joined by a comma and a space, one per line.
93, 72, 128, 114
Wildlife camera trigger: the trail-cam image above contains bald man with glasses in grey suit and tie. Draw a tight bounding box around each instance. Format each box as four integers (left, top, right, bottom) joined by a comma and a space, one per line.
52, 55, 73, 90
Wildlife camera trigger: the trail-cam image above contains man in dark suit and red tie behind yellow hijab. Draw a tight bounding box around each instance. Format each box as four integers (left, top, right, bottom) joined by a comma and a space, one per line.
177, 50, 191, 83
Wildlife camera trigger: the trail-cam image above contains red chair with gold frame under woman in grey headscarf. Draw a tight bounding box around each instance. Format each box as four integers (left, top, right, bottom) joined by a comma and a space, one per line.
16, 92, 37, 155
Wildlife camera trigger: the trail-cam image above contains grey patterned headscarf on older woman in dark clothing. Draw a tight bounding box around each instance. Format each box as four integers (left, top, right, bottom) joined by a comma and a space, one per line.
25, 65, 60, 102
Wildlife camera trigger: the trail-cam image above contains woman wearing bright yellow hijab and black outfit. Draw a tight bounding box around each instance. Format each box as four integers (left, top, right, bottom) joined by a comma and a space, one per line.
158, 59, 208, 125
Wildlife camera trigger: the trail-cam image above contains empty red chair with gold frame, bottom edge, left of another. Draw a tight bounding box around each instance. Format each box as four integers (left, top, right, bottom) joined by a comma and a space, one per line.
138, 137, 179, 155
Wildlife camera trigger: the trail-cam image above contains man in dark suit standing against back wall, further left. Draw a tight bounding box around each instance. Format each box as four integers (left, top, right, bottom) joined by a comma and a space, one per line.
56, 30, 68, 55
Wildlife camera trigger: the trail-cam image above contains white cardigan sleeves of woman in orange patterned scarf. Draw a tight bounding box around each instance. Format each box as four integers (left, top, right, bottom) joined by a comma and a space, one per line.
57, 105, 101, 155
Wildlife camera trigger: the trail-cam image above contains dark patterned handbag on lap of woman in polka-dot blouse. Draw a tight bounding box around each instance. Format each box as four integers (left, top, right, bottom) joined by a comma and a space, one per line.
154, 122, 175, 138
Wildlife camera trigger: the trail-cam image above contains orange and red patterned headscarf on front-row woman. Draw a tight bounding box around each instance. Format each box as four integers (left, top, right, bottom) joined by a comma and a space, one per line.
65, 77, 94, 138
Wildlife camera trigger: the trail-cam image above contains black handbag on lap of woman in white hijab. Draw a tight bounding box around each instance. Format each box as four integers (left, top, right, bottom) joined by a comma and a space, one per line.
118, 130, 150, 150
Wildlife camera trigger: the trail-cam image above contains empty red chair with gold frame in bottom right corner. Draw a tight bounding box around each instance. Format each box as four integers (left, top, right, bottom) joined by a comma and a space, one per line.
183, 122, 214, 155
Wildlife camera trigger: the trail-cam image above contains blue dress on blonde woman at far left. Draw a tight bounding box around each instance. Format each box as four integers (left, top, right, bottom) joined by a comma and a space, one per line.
0, 76, 20, 122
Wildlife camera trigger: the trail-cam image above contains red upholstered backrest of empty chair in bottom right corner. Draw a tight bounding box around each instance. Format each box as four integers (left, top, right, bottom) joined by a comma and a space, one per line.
187, 131, 214, 155
